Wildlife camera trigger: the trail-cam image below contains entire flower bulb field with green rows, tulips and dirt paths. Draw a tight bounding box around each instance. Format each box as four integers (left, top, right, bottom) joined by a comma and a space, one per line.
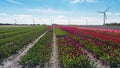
0, 26, 120, 68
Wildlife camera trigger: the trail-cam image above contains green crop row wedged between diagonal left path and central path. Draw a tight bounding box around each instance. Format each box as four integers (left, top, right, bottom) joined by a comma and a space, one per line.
20, 31, 53, 67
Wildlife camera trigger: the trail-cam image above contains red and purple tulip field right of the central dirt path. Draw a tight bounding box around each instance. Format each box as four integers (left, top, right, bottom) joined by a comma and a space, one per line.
57, 26, 120, 68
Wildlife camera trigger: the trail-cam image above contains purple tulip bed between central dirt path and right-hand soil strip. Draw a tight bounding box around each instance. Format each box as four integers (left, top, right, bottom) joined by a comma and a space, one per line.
55, 29, 93, 68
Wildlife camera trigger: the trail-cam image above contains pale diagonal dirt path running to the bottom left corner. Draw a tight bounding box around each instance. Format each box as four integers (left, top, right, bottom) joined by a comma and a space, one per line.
0, 31, 47, 68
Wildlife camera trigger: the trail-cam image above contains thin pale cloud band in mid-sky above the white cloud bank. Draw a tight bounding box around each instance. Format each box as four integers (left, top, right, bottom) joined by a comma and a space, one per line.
25, 8, 78, 16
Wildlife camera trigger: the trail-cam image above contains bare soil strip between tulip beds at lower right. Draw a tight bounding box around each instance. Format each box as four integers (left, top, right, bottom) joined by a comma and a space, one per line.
82, 48, 110, 68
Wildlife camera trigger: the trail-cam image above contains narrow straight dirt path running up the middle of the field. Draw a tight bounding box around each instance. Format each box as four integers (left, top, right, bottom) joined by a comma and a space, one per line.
49, 30, 60, 68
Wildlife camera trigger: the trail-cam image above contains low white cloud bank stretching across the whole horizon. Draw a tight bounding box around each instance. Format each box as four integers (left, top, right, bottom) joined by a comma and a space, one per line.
0, 12, 120, 25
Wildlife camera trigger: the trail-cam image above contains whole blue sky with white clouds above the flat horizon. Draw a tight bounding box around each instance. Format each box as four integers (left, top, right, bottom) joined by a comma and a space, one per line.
0, 0, 120, 25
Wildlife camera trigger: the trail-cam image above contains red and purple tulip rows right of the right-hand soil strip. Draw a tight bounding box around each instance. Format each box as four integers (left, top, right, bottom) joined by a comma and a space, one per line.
57, 26, 120, 66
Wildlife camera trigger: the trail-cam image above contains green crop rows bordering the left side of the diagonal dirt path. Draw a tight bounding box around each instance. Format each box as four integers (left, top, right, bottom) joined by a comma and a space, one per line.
0, 26, 47, 61
